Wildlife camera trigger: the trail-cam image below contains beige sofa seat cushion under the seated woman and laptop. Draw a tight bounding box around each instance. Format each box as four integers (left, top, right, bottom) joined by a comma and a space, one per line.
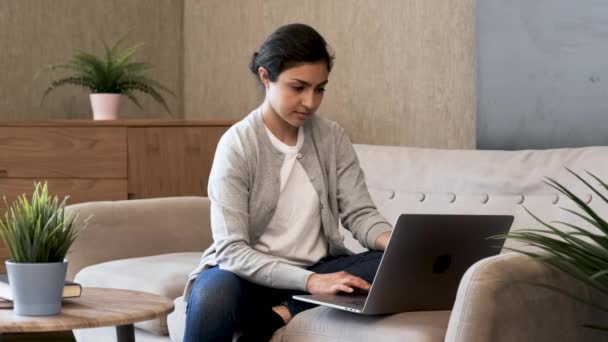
168, 297, 450, 342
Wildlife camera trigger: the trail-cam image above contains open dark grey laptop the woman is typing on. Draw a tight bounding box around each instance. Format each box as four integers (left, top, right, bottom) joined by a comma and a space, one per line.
293, 214, 513, 315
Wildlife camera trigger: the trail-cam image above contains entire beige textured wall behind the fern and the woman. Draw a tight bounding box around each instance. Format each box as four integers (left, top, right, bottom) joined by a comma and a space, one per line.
0, 0, 475, 148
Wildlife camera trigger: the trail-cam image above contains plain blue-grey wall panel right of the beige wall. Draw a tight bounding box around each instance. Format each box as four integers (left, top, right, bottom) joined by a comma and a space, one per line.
476, 0, 608, 149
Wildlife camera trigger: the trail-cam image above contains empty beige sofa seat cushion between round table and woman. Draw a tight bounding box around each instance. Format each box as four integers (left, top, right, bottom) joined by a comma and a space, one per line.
74, 252, 201, 335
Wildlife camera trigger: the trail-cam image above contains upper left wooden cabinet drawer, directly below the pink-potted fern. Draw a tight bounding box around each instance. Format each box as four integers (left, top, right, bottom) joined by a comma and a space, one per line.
0, 127, 127, 178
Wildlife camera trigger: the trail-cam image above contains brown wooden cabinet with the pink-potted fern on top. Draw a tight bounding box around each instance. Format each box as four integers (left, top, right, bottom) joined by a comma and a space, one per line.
0, 120, 233, 272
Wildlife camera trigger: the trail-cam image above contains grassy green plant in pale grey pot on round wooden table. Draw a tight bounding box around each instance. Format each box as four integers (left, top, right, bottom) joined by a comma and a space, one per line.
0, 183, 80, 316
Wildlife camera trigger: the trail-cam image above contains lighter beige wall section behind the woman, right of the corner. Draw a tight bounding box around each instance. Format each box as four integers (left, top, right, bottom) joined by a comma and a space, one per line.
184, 0, 475, 148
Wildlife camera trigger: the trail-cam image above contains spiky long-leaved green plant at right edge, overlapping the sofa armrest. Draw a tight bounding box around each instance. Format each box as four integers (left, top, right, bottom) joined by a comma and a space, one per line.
497, 169, 608, 330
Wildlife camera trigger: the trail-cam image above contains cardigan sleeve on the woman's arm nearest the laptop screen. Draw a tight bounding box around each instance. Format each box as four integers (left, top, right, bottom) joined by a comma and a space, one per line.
336, 126, 392, 249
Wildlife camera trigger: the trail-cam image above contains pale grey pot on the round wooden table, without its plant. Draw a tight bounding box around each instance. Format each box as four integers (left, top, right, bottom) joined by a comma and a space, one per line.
5, 260, 68, 316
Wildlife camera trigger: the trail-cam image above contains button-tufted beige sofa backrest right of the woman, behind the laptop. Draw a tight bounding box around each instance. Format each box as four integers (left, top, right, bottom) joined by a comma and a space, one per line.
345, 145, 608, 251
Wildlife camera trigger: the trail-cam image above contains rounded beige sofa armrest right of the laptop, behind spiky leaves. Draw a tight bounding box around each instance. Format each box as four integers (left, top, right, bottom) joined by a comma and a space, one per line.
445, 253, 608, 342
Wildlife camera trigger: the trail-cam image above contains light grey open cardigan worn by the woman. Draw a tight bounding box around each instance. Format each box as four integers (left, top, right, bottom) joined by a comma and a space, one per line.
185, 108, 392, 298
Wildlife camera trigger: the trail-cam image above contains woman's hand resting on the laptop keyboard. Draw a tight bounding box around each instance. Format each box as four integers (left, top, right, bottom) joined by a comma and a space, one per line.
306, 272, 371, 294
